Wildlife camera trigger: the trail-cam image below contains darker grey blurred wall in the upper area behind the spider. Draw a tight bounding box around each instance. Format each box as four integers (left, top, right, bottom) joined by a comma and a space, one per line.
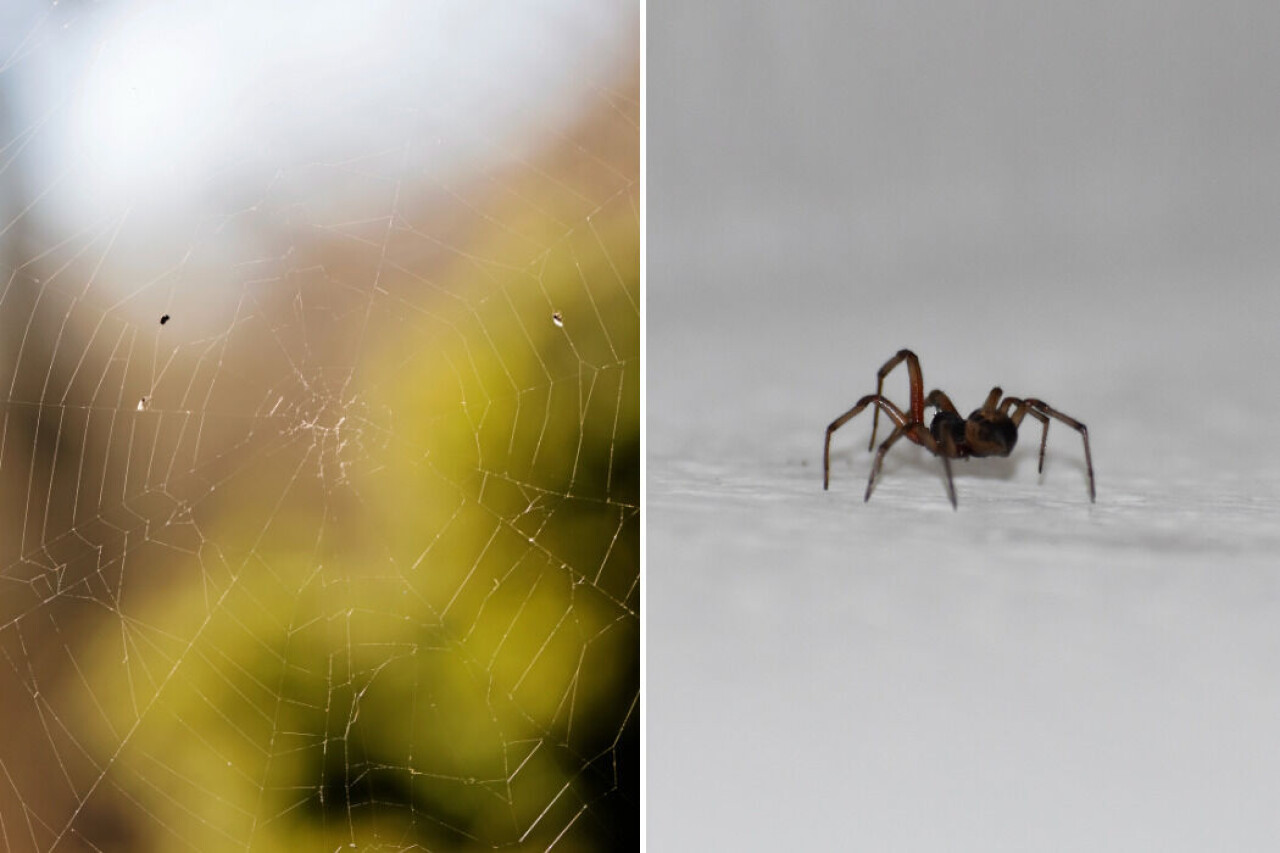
648, 1, 1280, 292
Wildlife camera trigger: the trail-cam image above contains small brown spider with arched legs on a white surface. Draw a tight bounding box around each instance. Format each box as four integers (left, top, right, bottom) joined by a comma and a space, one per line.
822, 350, 1096, 508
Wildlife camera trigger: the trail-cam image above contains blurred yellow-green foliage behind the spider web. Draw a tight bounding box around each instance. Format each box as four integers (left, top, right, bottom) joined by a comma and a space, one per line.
69, 195, 640, 850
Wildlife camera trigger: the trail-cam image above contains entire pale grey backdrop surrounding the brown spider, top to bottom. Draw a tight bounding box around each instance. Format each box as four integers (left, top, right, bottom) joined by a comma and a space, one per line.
645, 0, 1280, 850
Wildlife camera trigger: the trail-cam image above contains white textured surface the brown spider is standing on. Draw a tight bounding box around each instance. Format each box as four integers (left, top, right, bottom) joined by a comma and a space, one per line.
648, 292, 1280, 850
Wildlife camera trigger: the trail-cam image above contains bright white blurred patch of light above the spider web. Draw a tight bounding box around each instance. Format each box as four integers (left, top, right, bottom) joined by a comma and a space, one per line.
14, 0, 637, 239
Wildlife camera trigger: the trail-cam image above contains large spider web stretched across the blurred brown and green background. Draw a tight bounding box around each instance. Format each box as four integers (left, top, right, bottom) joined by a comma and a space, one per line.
0, 3, 640, 850
